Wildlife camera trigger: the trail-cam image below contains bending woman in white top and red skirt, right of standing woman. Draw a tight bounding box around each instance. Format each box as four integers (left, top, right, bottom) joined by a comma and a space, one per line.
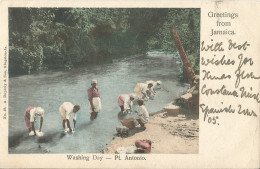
117, 93, 135, 112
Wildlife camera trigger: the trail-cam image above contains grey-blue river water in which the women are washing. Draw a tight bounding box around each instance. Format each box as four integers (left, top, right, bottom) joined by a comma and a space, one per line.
9, 52, 187, 154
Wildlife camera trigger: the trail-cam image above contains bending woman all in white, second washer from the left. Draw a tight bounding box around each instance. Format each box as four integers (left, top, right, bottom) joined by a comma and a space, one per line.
59, 102, 80, 132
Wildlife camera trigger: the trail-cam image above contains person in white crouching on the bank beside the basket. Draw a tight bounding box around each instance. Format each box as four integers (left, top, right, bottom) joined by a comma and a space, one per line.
136, 99, 149, 130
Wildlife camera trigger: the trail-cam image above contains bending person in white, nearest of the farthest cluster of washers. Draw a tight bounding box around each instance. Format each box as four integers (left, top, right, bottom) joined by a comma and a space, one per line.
134, 83, 153, 100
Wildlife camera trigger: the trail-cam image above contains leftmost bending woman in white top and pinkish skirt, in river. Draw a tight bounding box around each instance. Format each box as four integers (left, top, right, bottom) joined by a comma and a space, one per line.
24, 106, 44, 136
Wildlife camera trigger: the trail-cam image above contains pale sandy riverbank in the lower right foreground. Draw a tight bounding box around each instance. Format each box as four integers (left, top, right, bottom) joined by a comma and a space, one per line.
104, 111, 199, 154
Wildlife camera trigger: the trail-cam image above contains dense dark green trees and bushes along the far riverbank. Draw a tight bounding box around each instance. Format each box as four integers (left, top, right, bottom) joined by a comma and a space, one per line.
9, 8, 200, 76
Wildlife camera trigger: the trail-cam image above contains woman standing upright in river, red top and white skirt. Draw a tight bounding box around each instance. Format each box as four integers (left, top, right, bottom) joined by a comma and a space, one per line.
88, 80, 102, 120
